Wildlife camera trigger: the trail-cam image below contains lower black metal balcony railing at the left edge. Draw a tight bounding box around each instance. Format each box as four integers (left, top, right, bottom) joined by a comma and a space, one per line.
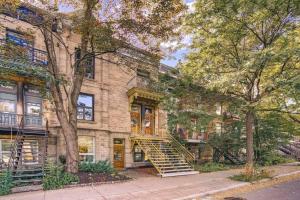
0, 112, 43, 128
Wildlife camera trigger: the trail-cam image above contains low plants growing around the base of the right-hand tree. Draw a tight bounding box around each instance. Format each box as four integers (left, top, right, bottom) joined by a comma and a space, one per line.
230, 169, 272, 182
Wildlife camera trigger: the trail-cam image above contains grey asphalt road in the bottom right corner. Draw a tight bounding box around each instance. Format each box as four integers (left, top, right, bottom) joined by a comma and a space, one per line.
230, 180, 300, 200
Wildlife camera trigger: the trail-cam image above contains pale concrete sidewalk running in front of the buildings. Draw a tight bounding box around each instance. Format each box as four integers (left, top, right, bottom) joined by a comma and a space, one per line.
0, 165, 300, 200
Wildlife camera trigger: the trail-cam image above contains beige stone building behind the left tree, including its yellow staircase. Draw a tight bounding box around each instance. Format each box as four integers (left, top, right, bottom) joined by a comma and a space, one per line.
0, 3, 199, 183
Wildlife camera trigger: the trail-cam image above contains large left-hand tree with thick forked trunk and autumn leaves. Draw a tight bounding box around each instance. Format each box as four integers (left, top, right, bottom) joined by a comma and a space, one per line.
1, 0, 185, 173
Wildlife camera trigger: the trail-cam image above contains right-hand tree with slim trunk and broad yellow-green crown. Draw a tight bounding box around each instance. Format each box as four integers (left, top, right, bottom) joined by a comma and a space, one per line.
182, 0, 300, 173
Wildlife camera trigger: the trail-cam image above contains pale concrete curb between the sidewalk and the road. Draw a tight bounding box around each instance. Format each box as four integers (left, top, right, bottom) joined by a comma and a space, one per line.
173, 170, 300, 200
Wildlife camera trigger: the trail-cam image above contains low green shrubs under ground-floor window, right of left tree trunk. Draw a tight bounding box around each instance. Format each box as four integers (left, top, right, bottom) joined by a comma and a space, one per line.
79, 160, 115, 174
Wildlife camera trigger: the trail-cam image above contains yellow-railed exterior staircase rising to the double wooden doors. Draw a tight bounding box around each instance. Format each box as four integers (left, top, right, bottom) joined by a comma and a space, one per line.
131, 135, 199, 177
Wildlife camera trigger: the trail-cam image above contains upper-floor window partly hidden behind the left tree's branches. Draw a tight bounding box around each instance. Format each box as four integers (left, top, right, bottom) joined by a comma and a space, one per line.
75, 48, 95, 79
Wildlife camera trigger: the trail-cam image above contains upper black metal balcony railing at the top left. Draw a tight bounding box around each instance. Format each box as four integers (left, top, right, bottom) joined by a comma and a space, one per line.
0, 39, 48, 66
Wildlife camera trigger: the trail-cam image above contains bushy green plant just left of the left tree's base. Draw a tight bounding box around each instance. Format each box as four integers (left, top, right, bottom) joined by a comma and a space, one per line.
43, 164, 79, 190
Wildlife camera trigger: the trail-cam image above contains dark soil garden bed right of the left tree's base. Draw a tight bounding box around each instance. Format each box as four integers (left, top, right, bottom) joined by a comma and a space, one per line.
76, 172, 130, 184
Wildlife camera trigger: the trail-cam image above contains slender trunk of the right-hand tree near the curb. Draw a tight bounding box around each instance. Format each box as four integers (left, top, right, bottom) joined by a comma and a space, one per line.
246, 110, 254, 175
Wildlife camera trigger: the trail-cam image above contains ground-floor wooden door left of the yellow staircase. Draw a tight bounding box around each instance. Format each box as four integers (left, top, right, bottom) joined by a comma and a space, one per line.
113, 139, 125, 169
